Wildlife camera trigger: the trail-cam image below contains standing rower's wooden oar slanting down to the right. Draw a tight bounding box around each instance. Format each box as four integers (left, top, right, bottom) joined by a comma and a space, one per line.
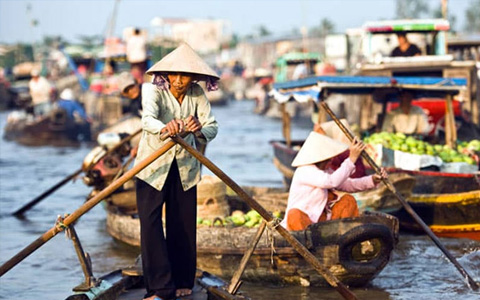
171, 136, 357, 299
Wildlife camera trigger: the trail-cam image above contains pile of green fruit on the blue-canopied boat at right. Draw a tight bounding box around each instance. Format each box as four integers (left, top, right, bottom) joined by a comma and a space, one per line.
363, 132, 480, 165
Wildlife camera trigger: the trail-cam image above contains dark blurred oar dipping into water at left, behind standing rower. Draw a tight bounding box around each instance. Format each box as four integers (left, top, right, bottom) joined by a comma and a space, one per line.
12, 129, 142, 217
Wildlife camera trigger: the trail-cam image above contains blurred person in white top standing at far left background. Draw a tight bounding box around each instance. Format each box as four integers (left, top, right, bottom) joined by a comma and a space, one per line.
28, 69, 52, 116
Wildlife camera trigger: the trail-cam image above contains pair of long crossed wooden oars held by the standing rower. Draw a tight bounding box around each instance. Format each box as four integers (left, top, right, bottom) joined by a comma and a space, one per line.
0, 134, 358, 299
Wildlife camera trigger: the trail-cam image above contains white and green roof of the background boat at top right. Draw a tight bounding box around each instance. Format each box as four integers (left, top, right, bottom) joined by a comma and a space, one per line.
363, 19, 450, 33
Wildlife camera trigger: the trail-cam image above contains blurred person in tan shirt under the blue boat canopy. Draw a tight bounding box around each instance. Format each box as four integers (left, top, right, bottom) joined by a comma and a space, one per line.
380, 90, 430, 135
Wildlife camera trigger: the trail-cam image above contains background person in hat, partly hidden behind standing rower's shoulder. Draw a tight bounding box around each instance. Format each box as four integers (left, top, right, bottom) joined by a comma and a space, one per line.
118, 72, 142, 117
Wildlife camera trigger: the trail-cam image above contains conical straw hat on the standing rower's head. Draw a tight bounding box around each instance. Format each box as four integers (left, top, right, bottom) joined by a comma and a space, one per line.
147, 43, 220, 79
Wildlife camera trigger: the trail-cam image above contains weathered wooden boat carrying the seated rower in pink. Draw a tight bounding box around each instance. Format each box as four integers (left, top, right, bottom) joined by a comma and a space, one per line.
99, 188, 399, 286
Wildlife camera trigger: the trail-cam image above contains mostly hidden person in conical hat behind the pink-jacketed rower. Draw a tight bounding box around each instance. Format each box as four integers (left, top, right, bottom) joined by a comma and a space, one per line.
313, 119, 366, 178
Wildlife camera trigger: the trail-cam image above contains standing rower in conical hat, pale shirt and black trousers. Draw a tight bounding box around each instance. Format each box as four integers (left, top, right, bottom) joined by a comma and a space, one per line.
135, 44, 219, 300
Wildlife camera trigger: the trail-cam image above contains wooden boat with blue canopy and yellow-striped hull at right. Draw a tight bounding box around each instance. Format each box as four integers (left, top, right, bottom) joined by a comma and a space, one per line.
271, 76, 480, 239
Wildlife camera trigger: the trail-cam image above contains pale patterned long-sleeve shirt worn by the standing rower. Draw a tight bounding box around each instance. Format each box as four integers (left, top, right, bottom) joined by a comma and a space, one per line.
135, 83, 218, 191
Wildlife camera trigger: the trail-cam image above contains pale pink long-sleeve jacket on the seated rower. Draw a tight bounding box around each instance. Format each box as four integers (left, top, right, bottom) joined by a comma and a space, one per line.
282, 158, 375, 228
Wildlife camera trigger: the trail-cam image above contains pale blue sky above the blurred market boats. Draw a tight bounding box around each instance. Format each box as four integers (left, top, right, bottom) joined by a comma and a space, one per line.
0, 0, 472, 44
